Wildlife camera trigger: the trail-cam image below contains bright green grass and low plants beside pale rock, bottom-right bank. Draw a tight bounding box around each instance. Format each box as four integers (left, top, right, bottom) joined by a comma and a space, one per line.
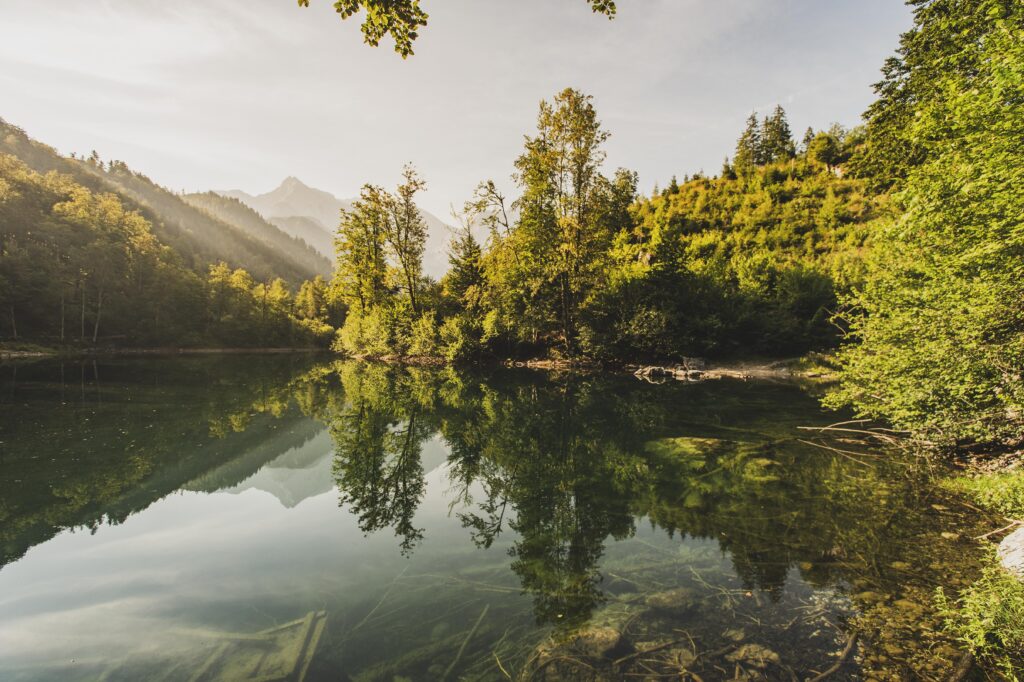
936, 470, 1024, 682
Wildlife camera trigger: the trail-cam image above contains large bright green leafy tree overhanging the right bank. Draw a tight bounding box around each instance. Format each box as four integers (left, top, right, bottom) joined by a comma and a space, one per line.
830, 11, 1024, 444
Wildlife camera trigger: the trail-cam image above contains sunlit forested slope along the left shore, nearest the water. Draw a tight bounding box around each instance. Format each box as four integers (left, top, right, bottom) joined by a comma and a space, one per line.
0, 147, 337, 346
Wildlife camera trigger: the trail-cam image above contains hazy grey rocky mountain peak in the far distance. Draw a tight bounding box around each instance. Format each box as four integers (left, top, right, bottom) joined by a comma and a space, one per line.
218, 176, 451, 278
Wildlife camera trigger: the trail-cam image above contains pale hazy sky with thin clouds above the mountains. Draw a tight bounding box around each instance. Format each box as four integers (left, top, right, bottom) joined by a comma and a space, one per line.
0, 0, 910, 217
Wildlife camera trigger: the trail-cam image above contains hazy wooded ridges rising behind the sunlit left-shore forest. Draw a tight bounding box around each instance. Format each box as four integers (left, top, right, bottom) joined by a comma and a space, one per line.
0, 119, 323, 287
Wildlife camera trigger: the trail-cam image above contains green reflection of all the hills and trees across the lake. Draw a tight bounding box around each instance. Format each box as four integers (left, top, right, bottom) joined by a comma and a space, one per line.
0, 357, 911, 625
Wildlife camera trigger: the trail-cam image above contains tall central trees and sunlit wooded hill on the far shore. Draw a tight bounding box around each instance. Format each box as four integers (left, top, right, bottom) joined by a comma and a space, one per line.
332, 89, 885, 361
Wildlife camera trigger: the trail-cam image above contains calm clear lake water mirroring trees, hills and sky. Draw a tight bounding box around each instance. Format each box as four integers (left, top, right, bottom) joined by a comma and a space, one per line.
0, 356, 973, 680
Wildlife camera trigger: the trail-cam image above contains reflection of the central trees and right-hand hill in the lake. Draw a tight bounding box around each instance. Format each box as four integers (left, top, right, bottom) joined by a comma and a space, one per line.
327, 364, 929, 626
